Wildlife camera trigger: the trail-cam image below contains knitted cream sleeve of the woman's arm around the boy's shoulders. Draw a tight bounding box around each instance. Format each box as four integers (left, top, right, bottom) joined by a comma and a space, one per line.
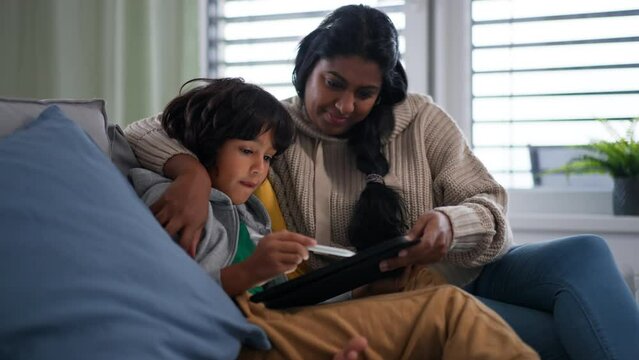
124, 115, 196, 174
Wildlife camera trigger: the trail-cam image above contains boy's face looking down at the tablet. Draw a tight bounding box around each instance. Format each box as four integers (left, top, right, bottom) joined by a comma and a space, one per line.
209, 130, 275, 205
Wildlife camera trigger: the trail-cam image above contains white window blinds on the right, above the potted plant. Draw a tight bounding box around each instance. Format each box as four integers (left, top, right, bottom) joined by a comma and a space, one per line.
471, 0, 639, 188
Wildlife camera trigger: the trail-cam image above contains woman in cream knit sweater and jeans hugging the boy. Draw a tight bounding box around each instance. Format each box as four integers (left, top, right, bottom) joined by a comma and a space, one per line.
126, 6, 639, 359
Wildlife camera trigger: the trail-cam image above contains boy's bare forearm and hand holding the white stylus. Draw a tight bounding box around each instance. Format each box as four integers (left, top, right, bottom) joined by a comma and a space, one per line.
220, 230, 316, 296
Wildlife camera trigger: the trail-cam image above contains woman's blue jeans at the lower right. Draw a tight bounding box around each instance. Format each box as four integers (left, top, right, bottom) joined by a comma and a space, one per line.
466, 235, 639, 360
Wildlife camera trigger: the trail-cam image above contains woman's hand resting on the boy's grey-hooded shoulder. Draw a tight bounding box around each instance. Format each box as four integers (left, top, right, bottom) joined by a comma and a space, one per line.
150, 154, 211, 257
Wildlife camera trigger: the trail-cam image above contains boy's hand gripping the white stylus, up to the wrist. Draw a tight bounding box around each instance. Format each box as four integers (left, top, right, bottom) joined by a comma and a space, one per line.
245, 230, 316, 283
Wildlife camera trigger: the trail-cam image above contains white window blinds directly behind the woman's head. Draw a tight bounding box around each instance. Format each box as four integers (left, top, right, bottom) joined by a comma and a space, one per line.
207, 0, 405, 99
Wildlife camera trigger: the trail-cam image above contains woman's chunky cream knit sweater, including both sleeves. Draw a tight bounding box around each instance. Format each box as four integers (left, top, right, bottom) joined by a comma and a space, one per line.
124, 94, 512, 286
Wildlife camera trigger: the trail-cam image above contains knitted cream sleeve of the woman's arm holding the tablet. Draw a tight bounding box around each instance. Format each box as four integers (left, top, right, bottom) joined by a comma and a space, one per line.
418, 103, 512, 267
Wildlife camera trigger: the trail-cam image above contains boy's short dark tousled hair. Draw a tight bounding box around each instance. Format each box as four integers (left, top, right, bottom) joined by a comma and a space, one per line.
161, 78, 295, 168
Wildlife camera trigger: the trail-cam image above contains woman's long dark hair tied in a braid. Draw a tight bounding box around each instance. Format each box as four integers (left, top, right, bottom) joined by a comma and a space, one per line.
293, 5, 408, 248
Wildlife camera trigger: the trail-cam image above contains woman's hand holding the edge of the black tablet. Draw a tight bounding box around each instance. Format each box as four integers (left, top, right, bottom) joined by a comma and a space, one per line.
379, 211, 453, 271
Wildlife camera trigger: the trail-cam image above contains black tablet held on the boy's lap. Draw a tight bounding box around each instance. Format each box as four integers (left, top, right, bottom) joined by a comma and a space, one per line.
250, 236, 419, 309
